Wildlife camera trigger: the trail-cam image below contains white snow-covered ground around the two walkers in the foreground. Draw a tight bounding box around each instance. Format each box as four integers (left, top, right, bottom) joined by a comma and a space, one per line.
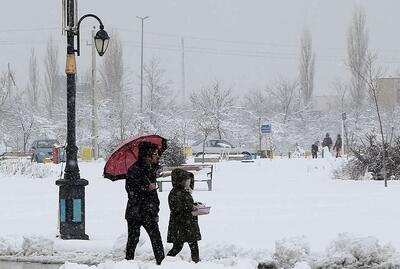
0, 158, 400, 269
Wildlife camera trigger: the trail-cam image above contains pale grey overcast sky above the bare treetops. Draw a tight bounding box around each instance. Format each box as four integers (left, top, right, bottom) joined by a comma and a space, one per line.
0, 0, 400, 98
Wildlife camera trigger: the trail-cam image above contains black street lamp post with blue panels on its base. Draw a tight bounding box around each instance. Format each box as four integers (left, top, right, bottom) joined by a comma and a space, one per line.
56, 0, 110, 240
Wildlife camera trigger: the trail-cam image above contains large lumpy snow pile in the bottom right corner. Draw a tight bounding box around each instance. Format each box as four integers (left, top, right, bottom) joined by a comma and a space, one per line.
316, 233, 400, 269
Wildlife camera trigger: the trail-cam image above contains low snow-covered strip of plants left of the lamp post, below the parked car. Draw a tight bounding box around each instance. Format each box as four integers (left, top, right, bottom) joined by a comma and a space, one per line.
0, 159, 60, 178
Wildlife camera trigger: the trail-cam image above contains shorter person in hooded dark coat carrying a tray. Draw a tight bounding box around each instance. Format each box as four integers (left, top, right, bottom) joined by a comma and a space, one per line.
167, 168, 201, 263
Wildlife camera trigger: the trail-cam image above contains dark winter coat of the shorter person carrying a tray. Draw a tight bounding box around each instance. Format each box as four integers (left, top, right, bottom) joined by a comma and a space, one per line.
167, 186, 201, 243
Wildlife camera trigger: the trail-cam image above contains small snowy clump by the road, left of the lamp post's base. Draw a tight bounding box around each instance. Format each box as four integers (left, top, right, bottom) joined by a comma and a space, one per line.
22, 236, 54, 256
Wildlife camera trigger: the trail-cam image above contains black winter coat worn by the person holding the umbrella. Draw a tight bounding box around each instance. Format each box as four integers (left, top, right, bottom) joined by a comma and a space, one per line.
125, 161, 160, 220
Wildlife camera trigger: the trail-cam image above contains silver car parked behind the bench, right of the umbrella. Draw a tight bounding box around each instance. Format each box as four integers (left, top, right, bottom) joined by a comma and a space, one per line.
192, 139, 253, 157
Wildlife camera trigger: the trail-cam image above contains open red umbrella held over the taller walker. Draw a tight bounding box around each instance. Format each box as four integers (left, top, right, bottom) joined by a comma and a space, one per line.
103, 135, 167, 181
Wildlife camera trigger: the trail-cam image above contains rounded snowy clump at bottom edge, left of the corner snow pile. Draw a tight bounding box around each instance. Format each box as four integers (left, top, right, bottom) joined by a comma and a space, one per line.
273, 237, 310, 269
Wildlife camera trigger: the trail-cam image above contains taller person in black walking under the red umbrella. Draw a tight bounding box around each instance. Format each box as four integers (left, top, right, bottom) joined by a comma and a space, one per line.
125, 142, 164, 265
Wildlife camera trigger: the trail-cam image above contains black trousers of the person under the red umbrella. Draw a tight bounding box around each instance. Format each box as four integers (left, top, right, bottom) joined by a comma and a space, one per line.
126, 218, 164, 264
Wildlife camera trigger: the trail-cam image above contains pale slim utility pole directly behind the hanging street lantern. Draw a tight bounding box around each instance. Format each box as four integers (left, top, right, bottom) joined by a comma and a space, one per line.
90, 27, 99, 160
